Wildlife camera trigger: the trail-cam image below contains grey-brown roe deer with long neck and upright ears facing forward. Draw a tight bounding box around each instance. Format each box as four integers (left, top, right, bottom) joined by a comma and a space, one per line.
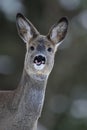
0, 13, 68, 130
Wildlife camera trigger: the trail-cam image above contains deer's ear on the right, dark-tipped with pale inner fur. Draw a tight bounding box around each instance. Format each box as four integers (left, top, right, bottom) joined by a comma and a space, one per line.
47, 17, 68, 46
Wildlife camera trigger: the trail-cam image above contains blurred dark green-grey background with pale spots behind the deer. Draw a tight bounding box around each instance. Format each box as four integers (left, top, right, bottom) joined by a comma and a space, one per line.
0, 0, 87, 130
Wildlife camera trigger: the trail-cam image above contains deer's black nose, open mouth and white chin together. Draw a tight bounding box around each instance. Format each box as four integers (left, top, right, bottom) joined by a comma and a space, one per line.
34, 55, 46, 70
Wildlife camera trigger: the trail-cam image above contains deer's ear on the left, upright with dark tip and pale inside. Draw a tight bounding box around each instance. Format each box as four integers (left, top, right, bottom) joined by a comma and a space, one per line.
16, 13, 39, 43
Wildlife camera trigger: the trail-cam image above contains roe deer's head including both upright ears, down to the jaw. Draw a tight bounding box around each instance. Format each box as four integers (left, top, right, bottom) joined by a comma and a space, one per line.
16, 13, 68, 80
